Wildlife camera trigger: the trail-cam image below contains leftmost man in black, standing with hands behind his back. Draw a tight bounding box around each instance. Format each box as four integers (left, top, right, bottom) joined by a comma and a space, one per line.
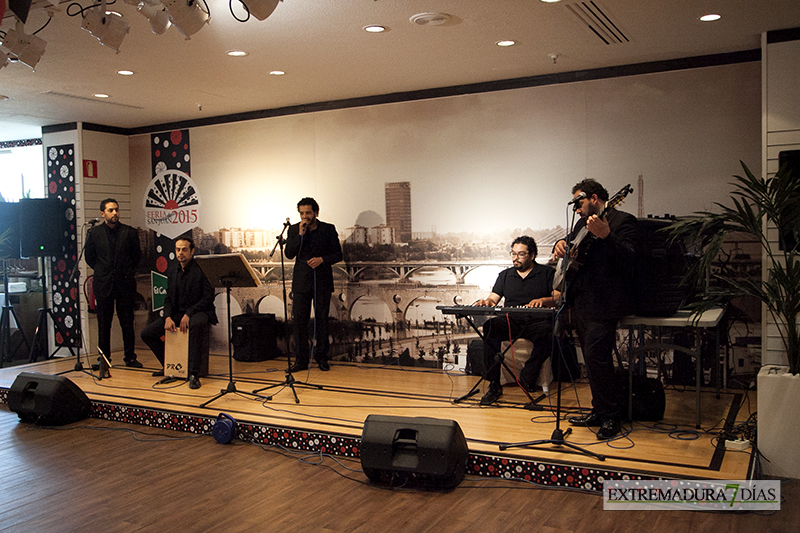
85, 198, 142, 368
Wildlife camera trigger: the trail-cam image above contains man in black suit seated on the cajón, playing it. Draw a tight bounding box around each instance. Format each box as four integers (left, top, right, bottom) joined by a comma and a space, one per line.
141, 237, 217, 389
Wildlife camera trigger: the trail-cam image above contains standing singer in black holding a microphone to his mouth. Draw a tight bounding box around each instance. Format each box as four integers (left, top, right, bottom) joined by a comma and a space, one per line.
285, 198, 342, 372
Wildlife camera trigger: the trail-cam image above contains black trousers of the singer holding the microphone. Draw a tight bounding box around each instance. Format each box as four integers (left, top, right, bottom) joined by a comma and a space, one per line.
292, 290, 331, 365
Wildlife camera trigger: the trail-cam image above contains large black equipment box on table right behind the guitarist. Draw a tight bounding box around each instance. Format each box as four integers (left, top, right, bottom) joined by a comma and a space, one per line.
634, 218, 694, 316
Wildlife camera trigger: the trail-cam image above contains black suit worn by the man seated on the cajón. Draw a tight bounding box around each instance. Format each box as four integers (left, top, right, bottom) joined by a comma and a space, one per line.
141, 259, 217, 376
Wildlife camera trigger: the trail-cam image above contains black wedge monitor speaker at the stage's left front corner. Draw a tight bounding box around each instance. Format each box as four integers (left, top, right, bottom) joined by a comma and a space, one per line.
8, 372, 92, 426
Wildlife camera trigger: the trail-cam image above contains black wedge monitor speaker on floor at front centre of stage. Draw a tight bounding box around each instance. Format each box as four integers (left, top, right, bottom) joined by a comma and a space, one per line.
361, 415, 469, 489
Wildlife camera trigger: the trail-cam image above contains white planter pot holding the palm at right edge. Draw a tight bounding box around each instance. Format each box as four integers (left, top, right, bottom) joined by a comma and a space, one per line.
758, 365, 800, 479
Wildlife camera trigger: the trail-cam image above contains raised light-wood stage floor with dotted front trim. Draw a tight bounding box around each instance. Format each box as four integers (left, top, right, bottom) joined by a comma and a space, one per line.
0, 349, 755, 490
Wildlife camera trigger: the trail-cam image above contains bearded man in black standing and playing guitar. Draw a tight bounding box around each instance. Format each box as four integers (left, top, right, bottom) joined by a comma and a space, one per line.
554, 179, 638, 440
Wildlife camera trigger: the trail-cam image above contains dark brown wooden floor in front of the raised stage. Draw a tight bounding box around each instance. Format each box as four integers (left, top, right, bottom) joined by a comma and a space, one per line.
0, 404, 800, 533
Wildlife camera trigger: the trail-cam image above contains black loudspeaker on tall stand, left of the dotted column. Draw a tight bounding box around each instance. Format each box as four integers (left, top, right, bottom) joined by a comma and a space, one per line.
19, 198, 67, 257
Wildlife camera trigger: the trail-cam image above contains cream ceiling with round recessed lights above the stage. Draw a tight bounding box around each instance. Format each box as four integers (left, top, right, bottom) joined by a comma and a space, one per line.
0, 0, 800, 141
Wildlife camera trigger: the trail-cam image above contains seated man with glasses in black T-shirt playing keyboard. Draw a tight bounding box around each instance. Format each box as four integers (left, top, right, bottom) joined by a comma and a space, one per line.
474, 235, 561, 405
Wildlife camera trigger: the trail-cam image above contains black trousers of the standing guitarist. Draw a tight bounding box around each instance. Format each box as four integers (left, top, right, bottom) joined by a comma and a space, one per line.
575, 313, 624, 418
